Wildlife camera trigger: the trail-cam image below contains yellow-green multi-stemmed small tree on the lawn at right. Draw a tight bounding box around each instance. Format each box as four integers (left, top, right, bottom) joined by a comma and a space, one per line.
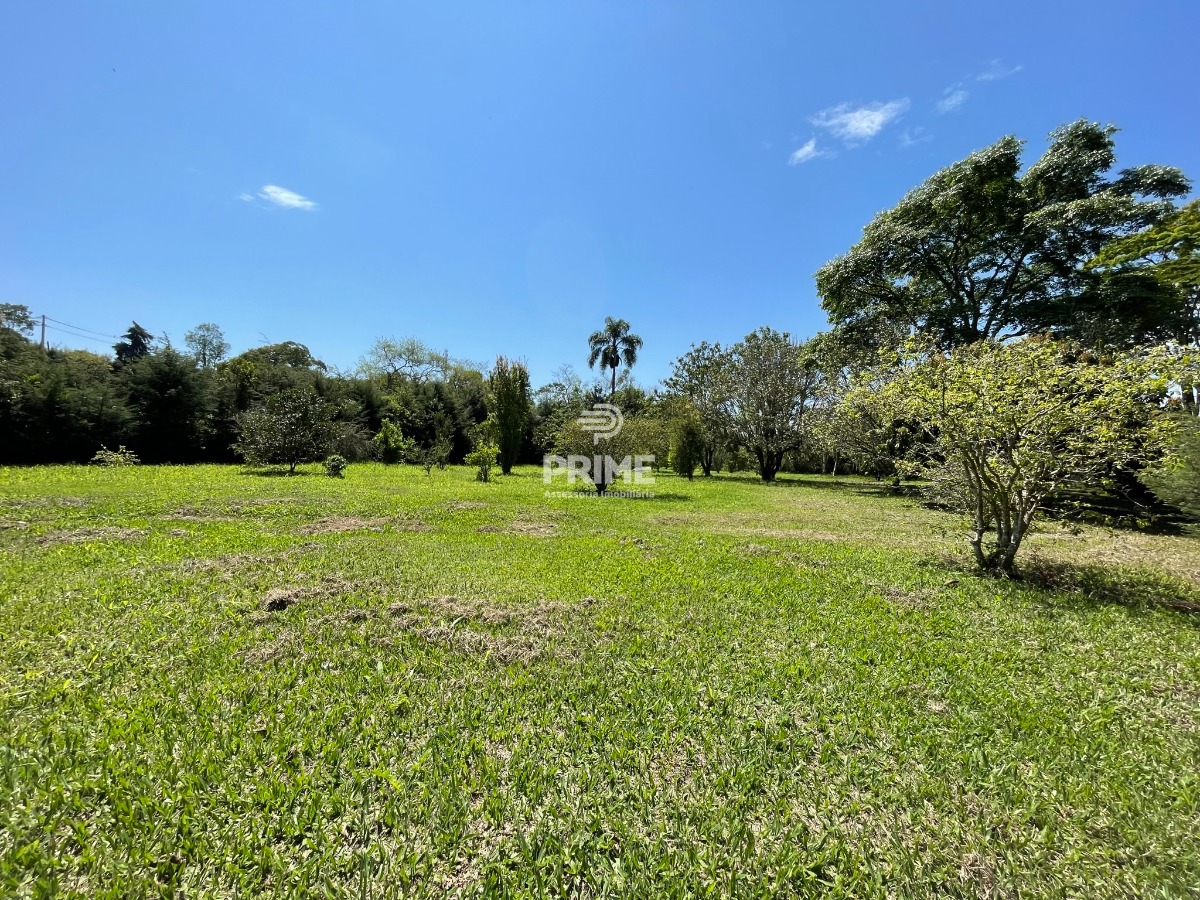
878, 340, 1176, 574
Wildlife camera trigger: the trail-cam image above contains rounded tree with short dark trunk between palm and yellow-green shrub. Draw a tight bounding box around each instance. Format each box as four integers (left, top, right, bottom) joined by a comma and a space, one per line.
722, 328, 821, 481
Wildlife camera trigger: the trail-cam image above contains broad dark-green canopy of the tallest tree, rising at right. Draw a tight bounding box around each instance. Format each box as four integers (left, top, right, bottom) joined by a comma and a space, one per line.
816, 120, 1190, 349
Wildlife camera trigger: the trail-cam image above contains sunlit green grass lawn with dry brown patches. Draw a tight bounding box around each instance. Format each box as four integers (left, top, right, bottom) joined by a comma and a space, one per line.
0, 466, 1200, 898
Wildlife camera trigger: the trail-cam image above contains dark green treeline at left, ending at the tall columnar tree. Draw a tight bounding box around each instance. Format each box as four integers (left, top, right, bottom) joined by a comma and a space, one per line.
0, 321, 487, 463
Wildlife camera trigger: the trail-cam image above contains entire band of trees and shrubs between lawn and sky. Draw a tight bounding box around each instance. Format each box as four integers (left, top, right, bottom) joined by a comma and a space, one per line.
0, 120, 1200, 565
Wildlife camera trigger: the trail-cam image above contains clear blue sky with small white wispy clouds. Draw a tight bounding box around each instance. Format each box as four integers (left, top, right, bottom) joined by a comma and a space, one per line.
0, 0, 1200, 384
